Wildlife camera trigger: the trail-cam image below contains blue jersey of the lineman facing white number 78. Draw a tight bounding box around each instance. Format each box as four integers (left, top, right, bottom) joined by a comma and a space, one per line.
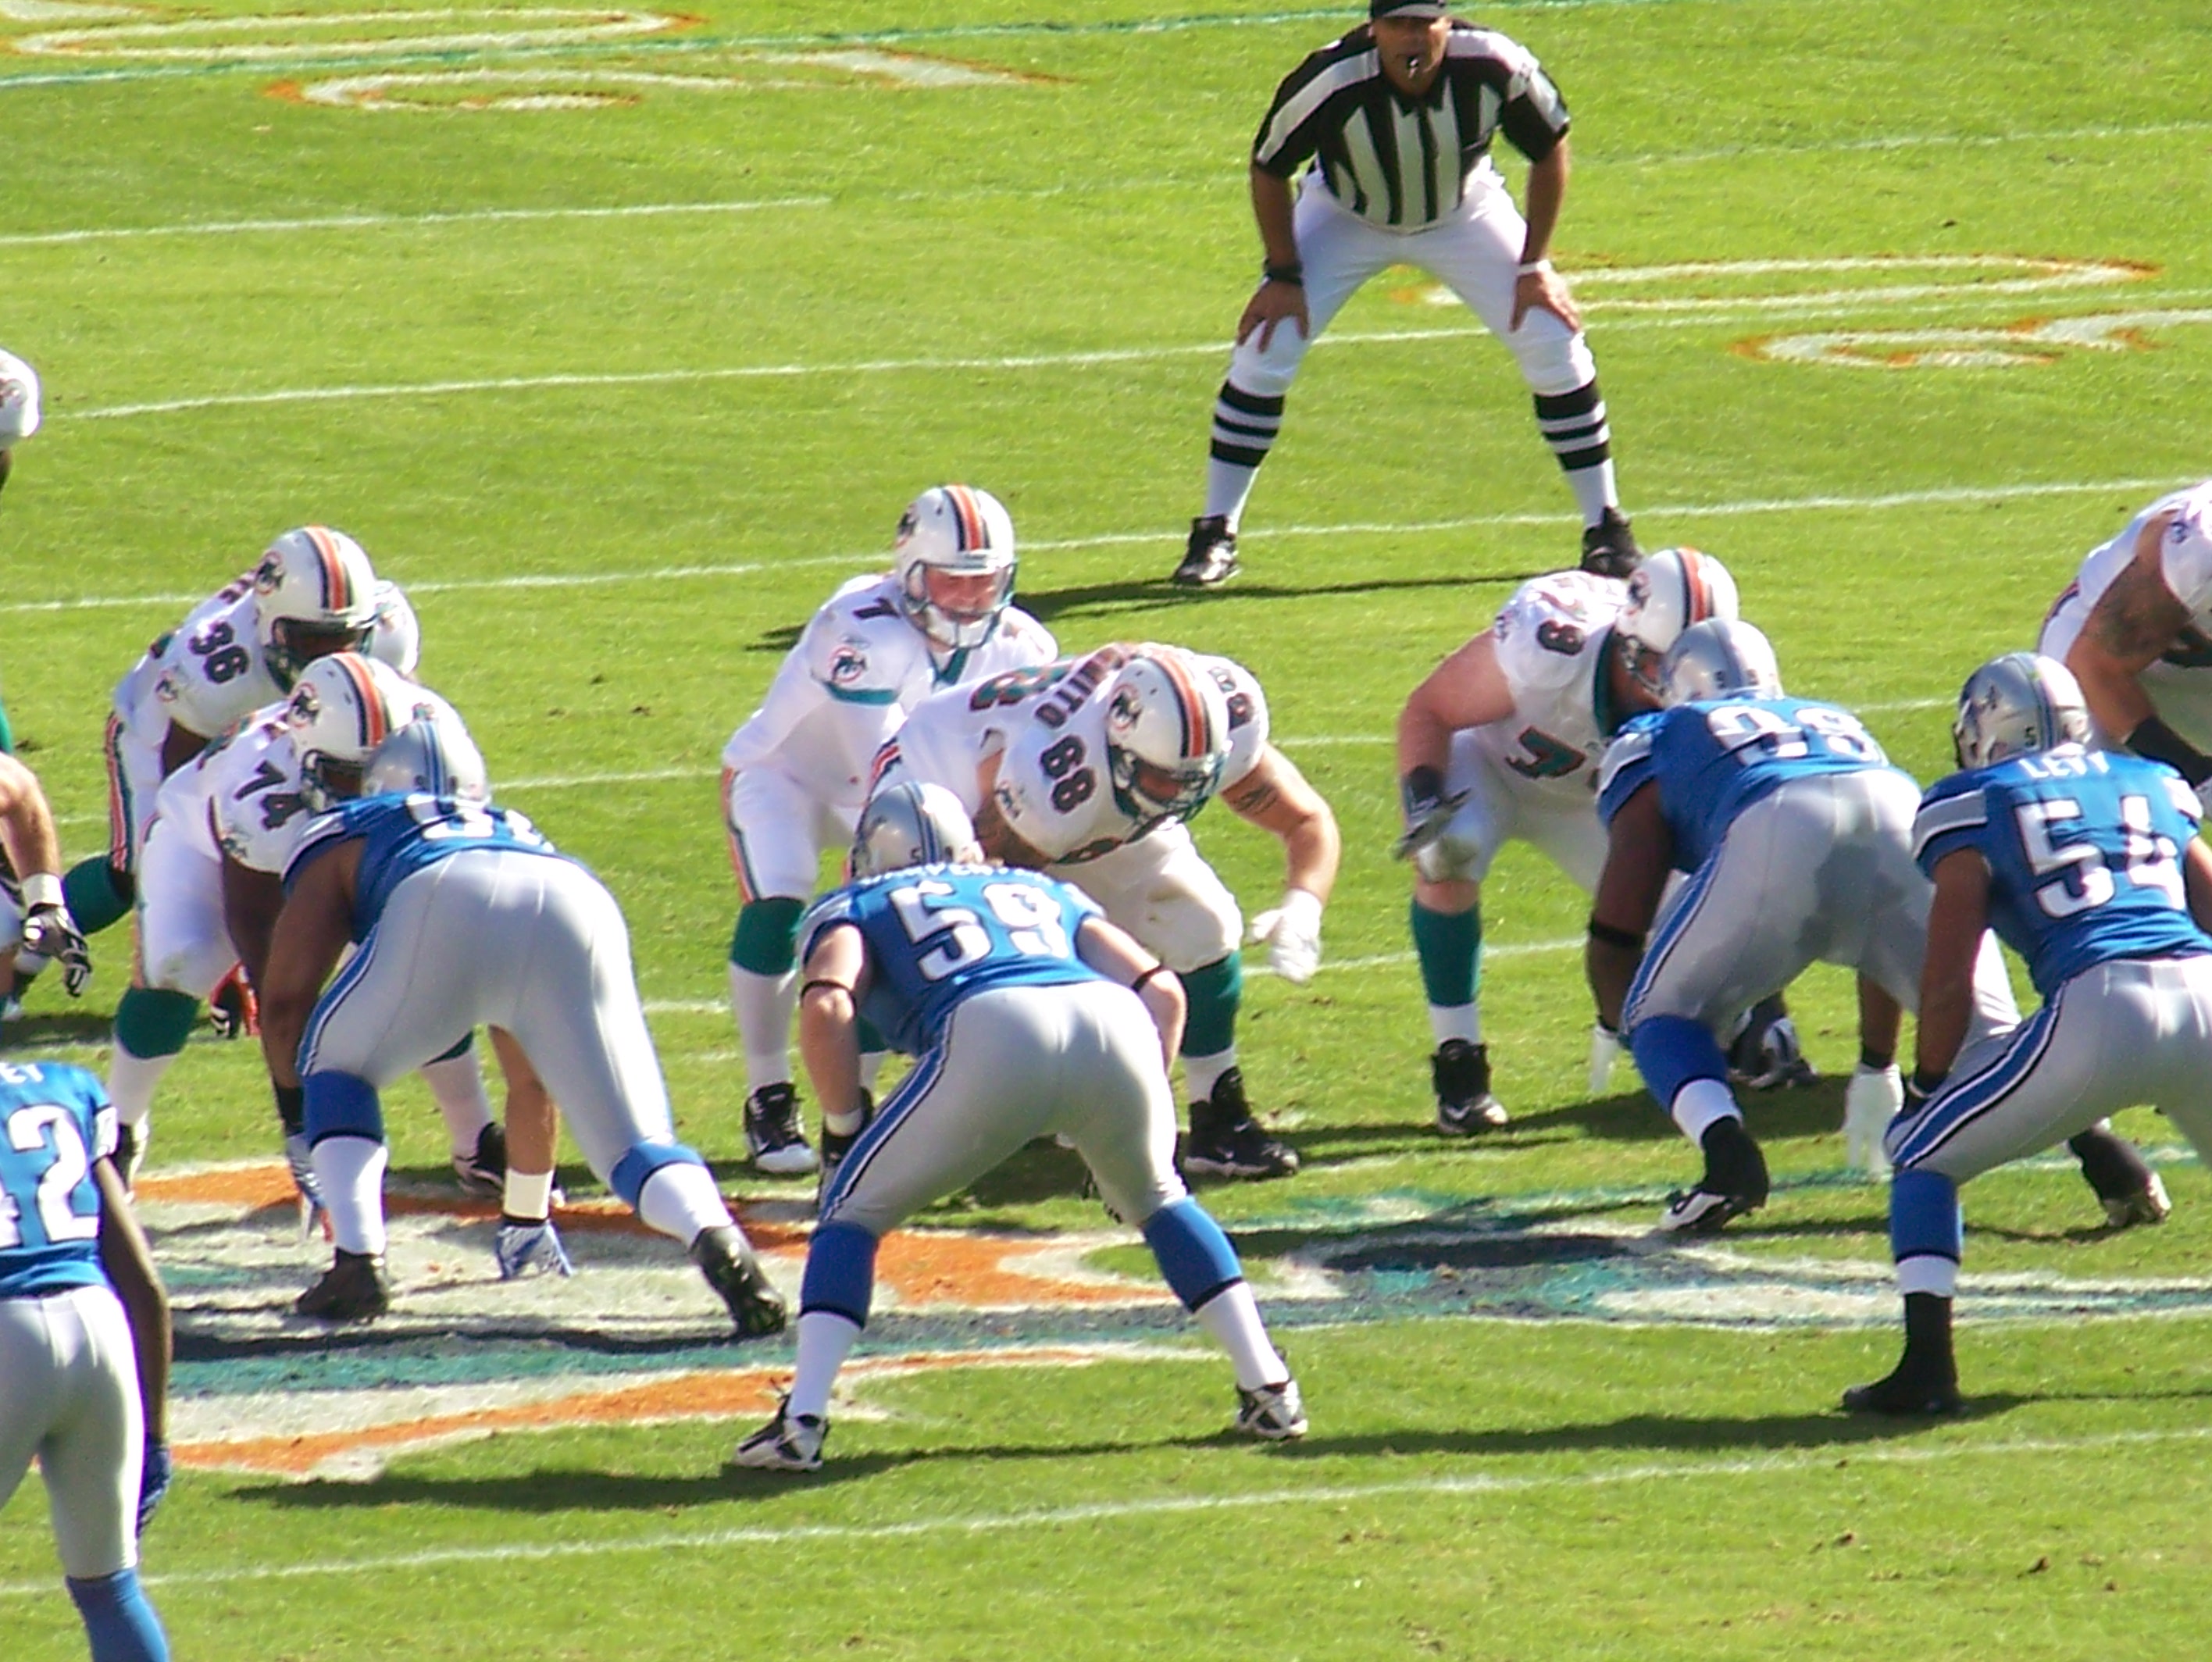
1597, 699, 1889, 872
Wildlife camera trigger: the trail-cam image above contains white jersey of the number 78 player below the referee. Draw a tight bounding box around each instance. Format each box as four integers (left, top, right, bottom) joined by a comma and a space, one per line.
1473, 571, 1628, 799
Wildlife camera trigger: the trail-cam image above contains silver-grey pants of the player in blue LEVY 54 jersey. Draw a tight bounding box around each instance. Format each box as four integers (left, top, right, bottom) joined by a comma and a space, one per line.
1885, 954, 2212, 1184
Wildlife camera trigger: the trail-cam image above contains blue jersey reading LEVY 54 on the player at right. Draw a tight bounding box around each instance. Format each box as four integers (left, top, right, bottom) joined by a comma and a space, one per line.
1914, 744, 2212, 998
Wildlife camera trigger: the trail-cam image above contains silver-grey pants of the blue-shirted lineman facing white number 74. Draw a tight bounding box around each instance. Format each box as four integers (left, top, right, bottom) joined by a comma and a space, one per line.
298, 847, 675, 1182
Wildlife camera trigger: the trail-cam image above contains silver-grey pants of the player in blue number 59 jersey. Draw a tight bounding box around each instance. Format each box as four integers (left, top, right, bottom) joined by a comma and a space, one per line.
821, 980, 1188, 1239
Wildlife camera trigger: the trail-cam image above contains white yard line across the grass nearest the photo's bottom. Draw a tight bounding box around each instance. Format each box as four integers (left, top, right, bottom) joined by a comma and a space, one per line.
0, 1418, 2212, 1598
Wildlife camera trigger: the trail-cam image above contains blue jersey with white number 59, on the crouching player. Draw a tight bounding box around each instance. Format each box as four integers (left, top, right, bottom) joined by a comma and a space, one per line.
798, 865, 1104, 1056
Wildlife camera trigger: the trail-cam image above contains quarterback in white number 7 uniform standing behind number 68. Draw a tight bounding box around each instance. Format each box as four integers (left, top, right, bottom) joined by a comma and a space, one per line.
721, 485, 1060, 1173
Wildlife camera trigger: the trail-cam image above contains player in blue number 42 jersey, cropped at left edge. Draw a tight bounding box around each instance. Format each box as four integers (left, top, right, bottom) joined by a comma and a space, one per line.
0, 1062, 170, 1662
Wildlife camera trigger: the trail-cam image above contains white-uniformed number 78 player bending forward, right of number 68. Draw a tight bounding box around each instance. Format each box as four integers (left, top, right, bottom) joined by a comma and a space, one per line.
1398, 549, 1736, 1136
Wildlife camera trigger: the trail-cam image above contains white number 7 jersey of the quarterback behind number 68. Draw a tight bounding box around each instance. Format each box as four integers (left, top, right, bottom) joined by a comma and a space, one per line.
721, 573, 1060, 808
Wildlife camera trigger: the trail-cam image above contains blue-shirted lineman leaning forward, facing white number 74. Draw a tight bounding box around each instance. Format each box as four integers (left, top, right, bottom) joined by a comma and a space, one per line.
261, 717, 783, 1335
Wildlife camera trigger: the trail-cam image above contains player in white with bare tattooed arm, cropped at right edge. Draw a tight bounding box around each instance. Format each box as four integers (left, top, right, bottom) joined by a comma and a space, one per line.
2035, 480, 2212, 786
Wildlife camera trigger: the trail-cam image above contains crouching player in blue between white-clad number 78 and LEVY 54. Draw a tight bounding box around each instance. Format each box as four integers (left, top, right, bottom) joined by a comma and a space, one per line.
1586, 619, 2018, 1232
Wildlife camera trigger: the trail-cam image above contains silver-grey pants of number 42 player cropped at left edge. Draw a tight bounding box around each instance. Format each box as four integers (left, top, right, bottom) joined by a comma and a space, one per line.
0, 1286, 146, 1580
